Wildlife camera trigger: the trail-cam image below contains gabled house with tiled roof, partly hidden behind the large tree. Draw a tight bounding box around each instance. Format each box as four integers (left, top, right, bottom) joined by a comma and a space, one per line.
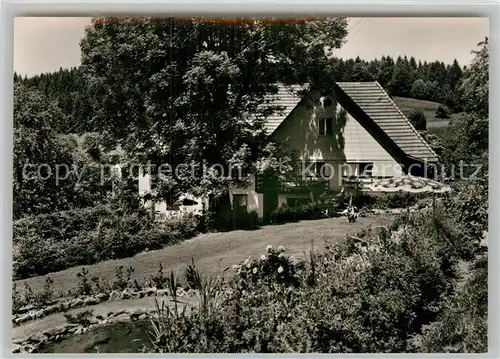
140, 82, 437, 218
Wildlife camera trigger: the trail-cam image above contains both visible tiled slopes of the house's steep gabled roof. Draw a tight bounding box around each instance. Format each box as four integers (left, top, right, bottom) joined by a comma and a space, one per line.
266, 82, 437, 162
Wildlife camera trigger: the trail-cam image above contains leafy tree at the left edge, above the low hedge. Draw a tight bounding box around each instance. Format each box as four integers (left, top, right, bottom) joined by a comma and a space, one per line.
13, 83, 109, 219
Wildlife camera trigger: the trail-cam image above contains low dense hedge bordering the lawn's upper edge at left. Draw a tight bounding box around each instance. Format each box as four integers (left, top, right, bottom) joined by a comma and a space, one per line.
13, 206, 199, 279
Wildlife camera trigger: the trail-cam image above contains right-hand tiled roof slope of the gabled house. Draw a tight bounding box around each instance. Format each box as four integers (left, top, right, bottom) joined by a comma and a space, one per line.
337, 82, 437, 161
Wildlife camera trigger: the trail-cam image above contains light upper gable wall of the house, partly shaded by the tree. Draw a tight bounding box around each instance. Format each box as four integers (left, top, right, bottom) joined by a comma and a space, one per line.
272, 91, 402, 190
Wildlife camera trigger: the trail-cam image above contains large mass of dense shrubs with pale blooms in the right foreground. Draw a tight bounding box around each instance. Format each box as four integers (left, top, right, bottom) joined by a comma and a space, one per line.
144, 207, 486, 353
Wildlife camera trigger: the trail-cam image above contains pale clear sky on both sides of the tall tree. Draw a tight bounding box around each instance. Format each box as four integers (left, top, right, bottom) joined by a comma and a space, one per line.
14, 17, 488, 76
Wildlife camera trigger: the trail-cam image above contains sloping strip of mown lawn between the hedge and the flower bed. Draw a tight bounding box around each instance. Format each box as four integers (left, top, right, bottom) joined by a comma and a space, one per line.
17, 216, 392, 293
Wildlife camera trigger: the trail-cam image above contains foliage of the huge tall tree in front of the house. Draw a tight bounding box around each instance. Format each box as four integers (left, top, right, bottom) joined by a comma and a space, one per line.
81, 18, 347, 200
